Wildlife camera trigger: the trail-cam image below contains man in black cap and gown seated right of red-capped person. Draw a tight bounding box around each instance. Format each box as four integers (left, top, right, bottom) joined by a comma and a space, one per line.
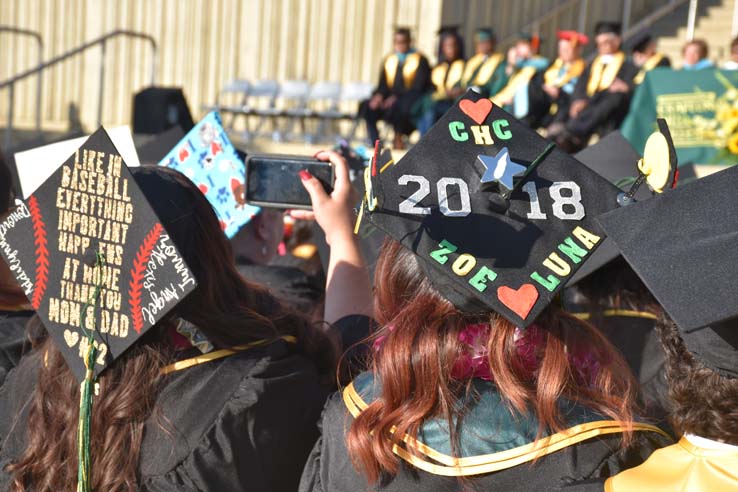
548, 21, 638, 152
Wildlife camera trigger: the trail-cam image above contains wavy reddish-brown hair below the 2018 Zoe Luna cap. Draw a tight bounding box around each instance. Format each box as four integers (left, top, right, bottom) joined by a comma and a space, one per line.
347, 241, 637, 483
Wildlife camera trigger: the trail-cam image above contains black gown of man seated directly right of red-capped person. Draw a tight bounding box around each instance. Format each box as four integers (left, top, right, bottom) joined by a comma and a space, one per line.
566, 59, 638, 141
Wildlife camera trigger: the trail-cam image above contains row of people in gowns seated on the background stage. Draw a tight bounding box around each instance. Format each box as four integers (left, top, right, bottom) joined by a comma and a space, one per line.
361, 21, 738, 152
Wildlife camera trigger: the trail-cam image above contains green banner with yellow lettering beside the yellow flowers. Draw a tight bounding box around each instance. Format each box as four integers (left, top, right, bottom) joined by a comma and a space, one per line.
620, 68, 738, 165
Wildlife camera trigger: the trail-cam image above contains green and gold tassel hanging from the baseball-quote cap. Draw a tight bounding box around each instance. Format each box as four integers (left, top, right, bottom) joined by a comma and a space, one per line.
77, 252, 105, 492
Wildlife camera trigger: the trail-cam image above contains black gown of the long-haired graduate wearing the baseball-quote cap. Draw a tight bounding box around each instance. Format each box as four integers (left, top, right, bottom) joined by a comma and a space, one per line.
0, 341, 327, 492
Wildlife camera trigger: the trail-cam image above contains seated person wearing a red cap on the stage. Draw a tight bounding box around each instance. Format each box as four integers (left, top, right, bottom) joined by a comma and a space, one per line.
523, 31, 589, 128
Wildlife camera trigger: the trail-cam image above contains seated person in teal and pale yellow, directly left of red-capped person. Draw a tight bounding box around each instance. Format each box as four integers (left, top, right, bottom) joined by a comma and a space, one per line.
490, 33, 549, 119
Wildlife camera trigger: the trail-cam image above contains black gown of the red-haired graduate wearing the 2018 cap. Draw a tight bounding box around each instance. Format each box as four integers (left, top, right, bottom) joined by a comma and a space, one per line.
299, 375, 671, 492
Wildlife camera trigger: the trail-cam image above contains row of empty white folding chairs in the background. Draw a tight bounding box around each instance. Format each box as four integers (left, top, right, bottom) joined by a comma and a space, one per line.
202, 79, 373, 143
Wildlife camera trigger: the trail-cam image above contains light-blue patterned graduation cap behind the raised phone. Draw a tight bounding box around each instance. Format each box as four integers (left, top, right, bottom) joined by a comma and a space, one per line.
159, 111, 261, 238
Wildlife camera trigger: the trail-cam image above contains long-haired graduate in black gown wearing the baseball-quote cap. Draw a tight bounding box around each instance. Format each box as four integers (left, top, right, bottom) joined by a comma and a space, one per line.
0, 129, 350, 492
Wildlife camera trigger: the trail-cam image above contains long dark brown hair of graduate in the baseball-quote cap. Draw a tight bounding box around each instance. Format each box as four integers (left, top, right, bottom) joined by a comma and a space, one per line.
6, 166, 335, 492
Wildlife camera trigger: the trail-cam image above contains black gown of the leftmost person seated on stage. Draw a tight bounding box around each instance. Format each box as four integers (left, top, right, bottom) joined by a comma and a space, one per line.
360, 52, 433, 141
